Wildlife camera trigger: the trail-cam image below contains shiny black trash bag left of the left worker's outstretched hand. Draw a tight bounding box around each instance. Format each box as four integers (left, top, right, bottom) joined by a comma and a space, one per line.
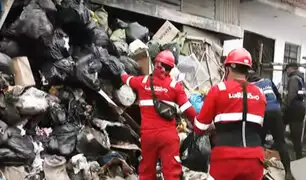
76, 54, 102, 90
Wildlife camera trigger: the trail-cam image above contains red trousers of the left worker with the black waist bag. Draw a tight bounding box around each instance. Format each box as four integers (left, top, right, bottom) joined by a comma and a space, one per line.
139, 129, 182, 180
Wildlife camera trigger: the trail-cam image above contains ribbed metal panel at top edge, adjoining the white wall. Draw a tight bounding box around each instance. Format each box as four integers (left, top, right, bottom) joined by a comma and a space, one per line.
215, 0, 240, 25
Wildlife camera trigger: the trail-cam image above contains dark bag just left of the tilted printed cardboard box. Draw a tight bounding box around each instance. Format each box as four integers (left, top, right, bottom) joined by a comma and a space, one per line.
125, 22, 149, 43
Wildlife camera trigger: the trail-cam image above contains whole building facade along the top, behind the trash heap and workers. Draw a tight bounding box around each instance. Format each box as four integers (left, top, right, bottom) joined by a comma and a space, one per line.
91, 0, 306, 84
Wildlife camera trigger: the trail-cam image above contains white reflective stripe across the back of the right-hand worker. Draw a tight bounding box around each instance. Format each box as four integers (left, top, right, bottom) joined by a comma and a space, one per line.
215, 113, 263, 125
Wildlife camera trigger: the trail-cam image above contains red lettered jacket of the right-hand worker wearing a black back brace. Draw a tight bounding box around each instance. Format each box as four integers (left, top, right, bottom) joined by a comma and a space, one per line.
194, 81, 266, 160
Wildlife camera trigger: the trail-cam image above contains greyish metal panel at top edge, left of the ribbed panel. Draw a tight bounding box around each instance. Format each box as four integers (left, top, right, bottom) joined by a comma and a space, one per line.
182, 0, 215, 19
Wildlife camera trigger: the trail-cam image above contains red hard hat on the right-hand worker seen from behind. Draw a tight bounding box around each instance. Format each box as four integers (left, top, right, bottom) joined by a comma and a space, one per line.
224, 48, 252, 68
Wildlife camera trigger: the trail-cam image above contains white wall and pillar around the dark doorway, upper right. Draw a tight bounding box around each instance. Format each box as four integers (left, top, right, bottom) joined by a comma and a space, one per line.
240, 1, 306, 83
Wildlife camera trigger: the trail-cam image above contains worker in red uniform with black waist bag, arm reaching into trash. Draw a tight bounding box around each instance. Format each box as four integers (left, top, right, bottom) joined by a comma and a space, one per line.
121, 50, 196, 180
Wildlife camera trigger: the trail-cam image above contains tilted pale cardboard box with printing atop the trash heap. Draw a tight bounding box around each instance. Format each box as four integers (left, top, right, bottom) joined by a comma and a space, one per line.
152, 21, 180, 45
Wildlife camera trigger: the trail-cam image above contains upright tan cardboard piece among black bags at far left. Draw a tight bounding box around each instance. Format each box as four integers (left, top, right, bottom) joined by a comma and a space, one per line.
12, 56, 35, 87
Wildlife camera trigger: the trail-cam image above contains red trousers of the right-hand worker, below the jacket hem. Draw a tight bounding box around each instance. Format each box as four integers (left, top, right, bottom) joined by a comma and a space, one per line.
210, 159, 264, 180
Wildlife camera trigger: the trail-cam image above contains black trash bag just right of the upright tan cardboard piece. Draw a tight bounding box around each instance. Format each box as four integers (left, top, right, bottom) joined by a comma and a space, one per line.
41, 57, 75, 84
